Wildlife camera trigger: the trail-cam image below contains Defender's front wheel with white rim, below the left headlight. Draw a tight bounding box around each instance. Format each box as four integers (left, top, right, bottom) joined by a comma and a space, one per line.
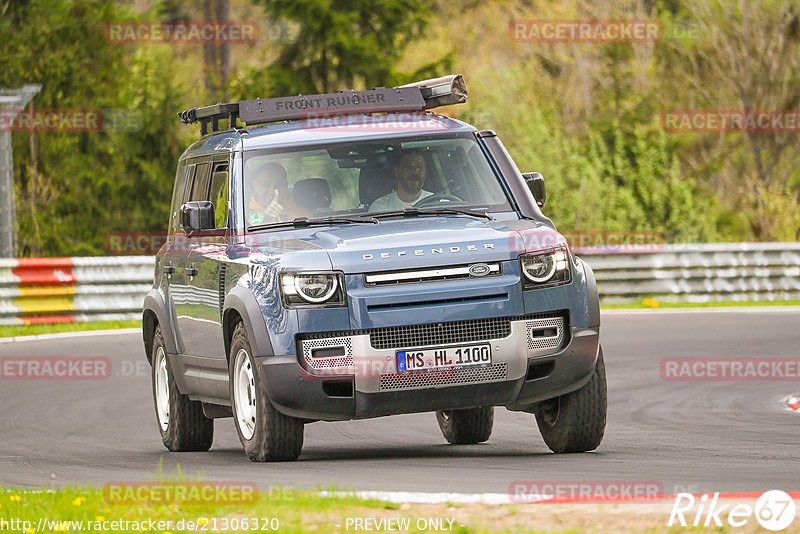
230, 323, 303, 462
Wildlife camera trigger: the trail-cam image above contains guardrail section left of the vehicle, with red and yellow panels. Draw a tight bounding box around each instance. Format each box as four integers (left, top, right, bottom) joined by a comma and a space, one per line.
0, 256, 154, 325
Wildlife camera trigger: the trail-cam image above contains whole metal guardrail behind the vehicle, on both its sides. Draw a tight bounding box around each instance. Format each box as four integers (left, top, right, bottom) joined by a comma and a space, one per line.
0, 243, 800, 324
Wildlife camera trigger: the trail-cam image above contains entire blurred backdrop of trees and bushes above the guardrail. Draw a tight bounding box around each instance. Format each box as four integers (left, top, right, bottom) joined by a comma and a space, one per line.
0, 0, 800, 256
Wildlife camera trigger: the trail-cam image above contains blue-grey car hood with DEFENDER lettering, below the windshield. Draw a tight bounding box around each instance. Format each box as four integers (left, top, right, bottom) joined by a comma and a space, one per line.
241, 216, 557, 273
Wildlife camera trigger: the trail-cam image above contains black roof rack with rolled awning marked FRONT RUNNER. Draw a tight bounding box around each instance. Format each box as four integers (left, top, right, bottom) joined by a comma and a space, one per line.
178, 74, 467, 135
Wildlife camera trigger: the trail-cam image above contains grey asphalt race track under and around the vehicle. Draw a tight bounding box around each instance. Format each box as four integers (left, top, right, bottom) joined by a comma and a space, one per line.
0, 308, 800, 493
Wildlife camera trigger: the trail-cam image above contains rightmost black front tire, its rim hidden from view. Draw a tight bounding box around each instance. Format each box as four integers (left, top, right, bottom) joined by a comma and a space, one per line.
536, 348, 607, 453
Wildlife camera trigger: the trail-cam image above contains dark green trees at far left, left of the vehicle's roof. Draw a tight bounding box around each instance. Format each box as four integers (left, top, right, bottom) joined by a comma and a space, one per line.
0, 0, 184, 256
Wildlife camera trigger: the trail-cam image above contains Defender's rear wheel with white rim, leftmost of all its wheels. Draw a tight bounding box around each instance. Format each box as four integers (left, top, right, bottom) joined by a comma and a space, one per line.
151, 326, 214, 452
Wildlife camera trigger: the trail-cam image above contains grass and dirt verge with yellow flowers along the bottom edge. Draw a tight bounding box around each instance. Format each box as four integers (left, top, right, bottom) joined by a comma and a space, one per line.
0, 483, 740, 534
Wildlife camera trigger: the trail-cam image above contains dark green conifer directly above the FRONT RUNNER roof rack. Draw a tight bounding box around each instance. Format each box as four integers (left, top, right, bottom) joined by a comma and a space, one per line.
248, 0, 449, 95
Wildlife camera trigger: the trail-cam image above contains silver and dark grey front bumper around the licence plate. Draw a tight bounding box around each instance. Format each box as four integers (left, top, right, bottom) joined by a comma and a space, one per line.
258, 314, 599, 421
